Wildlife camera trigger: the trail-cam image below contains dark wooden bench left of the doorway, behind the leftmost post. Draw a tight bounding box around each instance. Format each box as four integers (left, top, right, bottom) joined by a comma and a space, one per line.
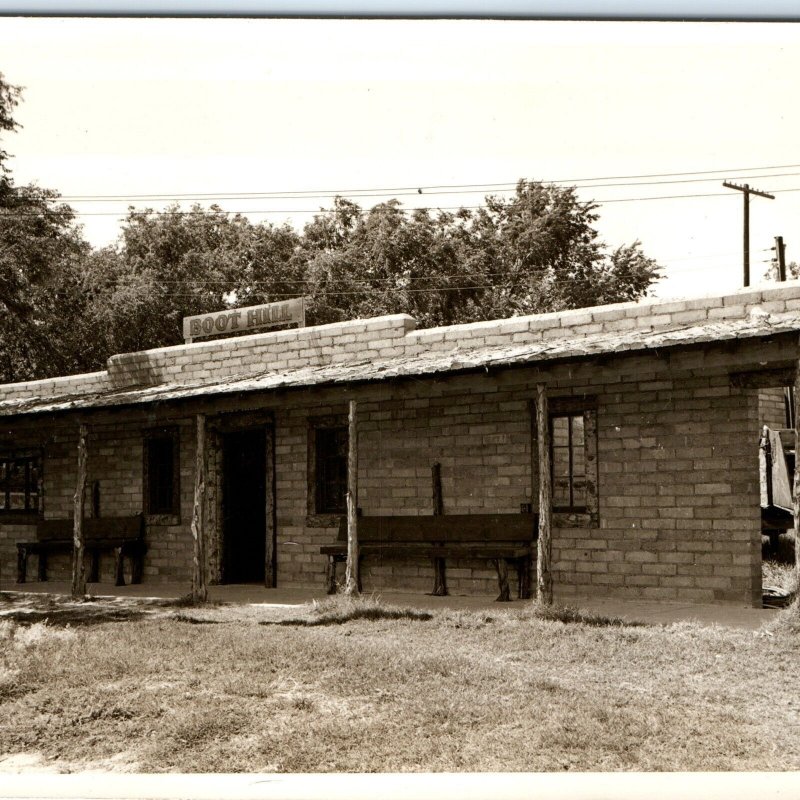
17, 514, 145, 586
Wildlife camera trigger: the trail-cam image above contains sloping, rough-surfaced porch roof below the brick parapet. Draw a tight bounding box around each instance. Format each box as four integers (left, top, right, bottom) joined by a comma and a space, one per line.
0, 311, 800, 417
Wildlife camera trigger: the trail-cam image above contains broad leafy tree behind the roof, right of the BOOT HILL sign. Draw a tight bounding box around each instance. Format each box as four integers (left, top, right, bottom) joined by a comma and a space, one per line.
301, 181, 659, 327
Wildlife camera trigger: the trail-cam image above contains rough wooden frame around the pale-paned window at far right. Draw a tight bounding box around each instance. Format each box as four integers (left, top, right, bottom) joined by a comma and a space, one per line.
530, 395, 600, 528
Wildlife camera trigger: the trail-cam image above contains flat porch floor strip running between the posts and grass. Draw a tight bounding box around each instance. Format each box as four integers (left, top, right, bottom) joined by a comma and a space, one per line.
0, 581, 778, 630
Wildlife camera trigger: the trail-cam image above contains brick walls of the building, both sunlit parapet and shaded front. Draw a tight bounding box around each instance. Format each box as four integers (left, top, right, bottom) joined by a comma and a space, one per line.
6, 283, 800, 603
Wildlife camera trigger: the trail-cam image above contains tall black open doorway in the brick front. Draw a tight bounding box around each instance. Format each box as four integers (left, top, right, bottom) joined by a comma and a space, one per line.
222, 428, 271, 583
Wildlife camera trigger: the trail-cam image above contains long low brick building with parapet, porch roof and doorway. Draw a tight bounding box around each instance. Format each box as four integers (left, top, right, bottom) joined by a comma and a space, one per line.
0, 282, 800, 604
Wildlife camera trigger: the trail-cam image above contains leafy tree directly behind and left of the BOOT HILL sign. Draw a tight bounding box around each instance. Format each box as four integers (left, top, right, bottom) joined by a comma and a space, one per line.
91, 205, 304, 352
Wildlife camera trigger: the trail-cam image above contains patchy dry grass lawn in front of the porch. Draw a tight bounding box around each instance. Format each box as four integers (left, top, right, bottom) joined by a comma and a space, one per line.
0, 598, 800, 772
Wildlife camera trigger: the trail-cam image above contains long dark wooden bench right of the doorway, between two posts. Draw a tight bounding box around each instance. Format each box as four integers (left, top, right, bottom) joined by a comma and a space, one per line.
320, 514, 537, 601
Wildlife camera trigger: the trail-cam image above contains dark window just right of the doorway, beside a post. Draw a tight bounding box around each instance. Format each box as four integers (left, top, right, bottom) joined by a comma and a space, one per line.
308, 418, 348, 515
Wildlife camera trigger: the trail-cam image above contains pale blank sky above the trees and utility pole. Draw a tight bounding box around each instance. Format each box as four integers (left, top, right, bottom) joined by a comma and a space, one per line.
0, 17, 800, 297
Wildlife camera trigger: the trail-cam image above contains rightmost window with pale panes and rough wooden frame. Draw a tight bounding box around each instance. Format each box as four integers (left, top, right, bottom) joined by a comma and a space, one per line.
531, 397, 599, 527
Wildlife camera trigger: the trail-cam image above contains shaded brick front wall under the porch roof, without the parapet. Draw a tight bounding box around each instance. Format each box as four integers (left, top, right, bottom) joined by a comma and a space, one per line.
0, 334, 780, 603
